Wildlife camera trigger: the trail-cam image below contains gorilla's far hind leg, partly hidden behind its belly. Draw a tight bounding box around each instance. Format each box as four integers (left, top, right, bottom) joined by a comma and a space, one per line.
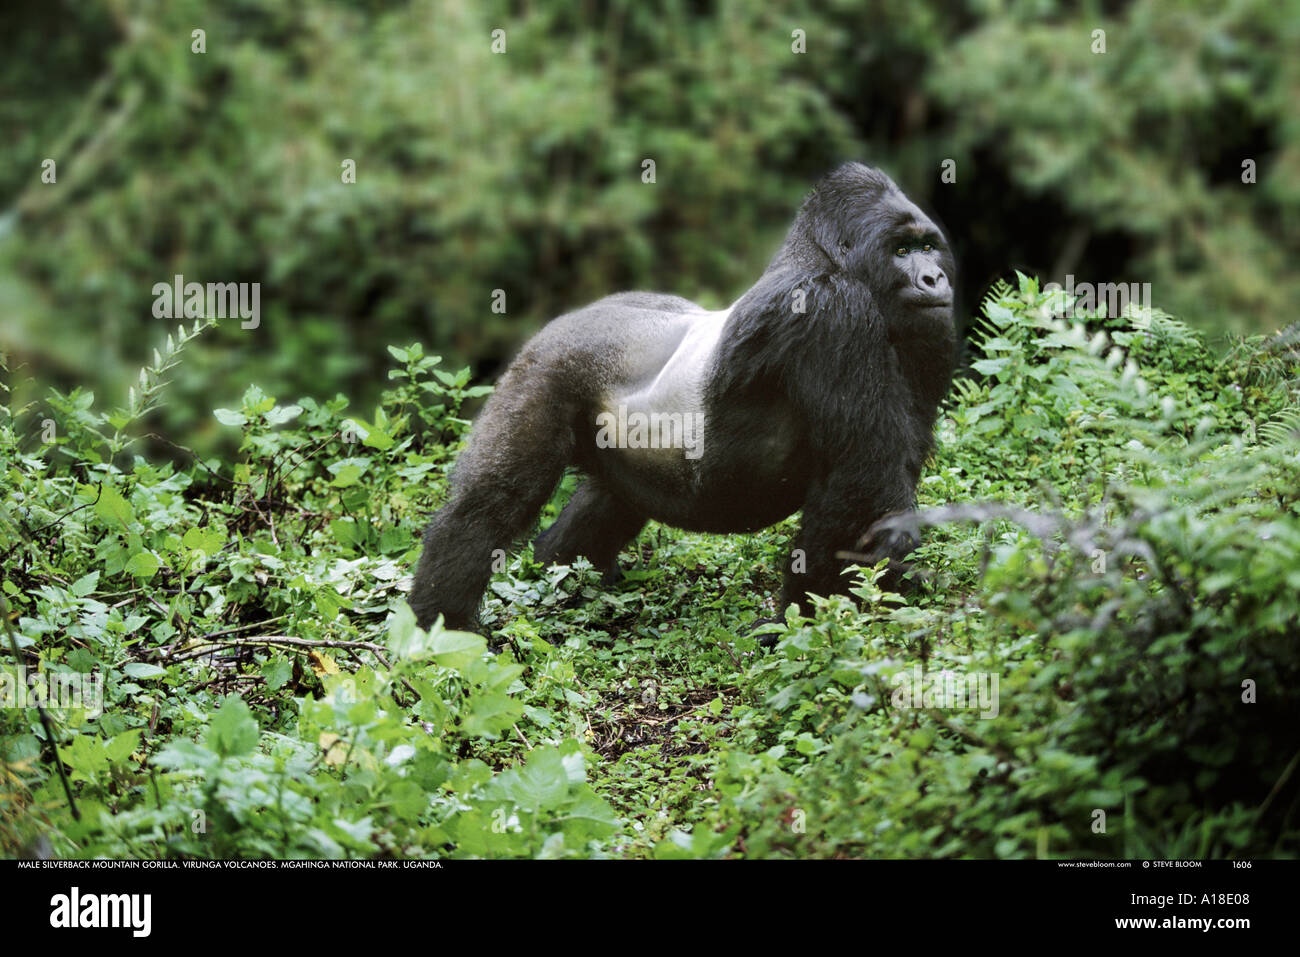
533, 479, 646, 585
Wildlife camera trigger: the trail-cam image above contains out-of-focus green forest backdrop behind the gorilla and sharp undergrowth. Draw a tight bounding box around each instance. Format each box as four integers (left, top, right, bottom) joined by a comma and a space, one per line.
0, 0, 1300, 443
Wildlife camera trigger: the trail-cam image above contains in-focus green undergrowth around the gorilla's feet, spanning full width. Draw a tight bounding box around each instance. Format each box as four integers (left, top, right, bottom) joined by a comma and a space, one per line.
0, 277, 1300, 858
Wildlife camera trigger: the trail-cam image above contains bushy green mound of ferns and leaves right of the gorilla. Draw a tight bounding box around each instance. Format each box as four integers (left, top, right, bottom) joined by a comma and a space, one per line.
702, 277, 1300, 857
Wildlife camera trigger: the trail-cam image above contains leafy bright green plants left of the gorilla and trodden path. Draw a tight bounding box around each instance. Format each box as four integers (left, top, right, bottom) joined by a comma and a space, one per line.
0, 328, 618, 857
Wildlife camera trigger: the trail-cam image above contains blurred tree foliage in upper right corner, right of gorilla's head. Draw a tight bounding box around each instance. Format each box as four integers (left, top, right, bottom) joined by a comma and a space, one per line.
926, 0, 1300, 348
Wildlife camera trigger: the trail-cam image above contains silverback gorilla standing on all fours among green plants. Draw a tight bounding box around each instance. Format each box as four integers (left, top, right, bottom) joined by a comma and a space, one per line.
411, 163, 956, 631
